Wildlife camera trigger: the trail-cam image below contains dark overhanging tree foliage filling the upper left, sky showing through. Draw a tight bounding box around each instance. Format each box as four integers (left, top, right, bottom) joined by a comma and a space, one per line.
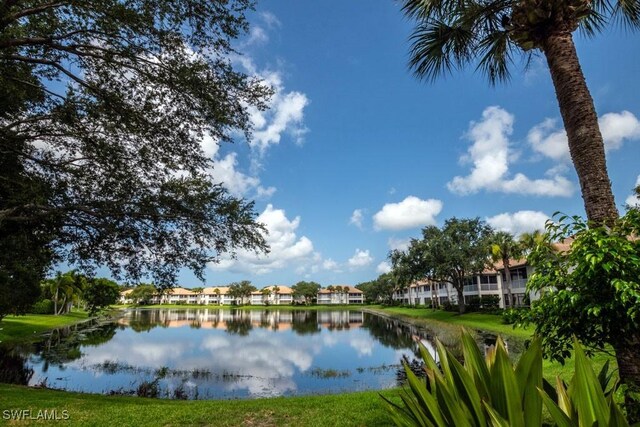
0, 0, 272, 290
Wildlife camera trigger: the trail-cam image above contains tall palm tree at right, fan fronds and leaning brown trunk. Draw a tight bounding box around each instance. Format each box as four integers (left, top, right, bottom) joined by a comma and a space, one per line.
402, 0, 640, 223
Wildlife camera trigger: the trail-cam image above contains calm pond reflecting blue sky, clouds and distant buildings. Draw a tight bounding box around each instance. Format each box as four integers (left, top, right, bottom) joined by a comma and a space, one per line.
0, 308, 516, 399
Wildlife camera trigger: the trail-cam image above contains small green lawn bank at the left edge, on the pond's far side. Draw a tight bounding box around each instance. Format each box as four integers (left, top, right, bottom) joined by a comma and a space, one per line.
0, 310, 89, 343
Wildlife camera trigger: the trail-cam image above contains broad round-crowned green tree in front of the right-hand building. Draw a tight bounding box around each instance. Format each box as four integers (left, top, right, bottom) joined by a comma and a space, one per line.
390, 217, 492, 313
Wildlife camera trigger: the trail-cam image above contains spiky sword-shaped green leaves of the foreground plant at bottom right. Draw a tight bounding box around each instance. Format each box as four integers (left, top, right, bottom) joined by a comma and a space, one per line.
383, 330, 628, 427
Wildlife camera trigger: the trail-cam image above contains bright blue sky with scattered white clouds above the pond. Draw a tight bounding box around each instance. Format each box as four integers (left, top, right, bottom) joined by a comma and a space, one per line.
151, 0, 640, 287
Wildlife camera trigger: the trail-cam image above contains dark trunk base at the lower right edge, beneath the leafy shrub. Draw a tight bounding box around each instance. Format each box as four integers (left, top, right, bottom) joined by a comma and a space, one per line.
615, 334, 640, 424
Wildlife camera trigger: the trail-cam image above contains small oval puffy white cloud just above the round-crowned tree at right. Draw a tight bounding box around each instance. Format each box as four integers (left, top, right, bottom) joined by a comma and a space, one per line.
373, 196, 442, 230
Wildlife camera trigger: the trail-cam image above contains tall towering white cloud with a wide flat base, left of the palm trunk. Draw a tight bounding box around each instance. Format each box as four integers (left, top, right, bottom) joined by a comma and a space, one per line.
447, 106, 573, 197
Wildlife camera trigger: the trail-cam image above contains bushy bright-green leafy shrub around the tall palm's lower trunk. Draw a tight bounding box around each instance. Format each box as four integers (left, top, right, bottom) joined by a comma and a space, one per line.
528, 210, 640, 361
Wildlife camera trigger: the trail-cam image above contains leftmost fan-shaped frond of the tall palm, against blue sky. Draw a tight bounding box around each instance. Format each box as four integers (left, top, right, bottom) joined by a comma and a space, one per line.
409, 20, 474, 80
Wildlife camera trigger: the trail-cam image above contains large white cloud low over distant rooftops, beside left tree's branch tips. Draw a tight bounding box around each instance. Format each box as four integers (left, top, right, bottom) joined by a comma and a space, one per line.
209, 204, 314, 274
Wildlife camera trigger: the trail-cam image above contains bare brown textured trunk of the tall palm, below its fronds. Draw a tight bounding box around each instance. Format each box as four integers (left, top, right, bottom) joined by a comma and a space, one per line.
543, 31, 618, 223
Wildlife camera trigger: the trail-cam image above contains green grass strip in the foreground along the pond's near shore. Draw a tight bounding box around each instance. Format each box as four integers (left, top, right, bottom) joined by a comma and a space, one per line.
0, 384, 397, 427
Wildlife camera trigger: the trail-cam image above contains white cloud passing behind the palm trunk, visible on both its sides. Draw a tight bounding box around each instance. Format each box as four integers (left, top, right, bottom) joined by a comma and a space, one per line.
527, 111, 640, 161
